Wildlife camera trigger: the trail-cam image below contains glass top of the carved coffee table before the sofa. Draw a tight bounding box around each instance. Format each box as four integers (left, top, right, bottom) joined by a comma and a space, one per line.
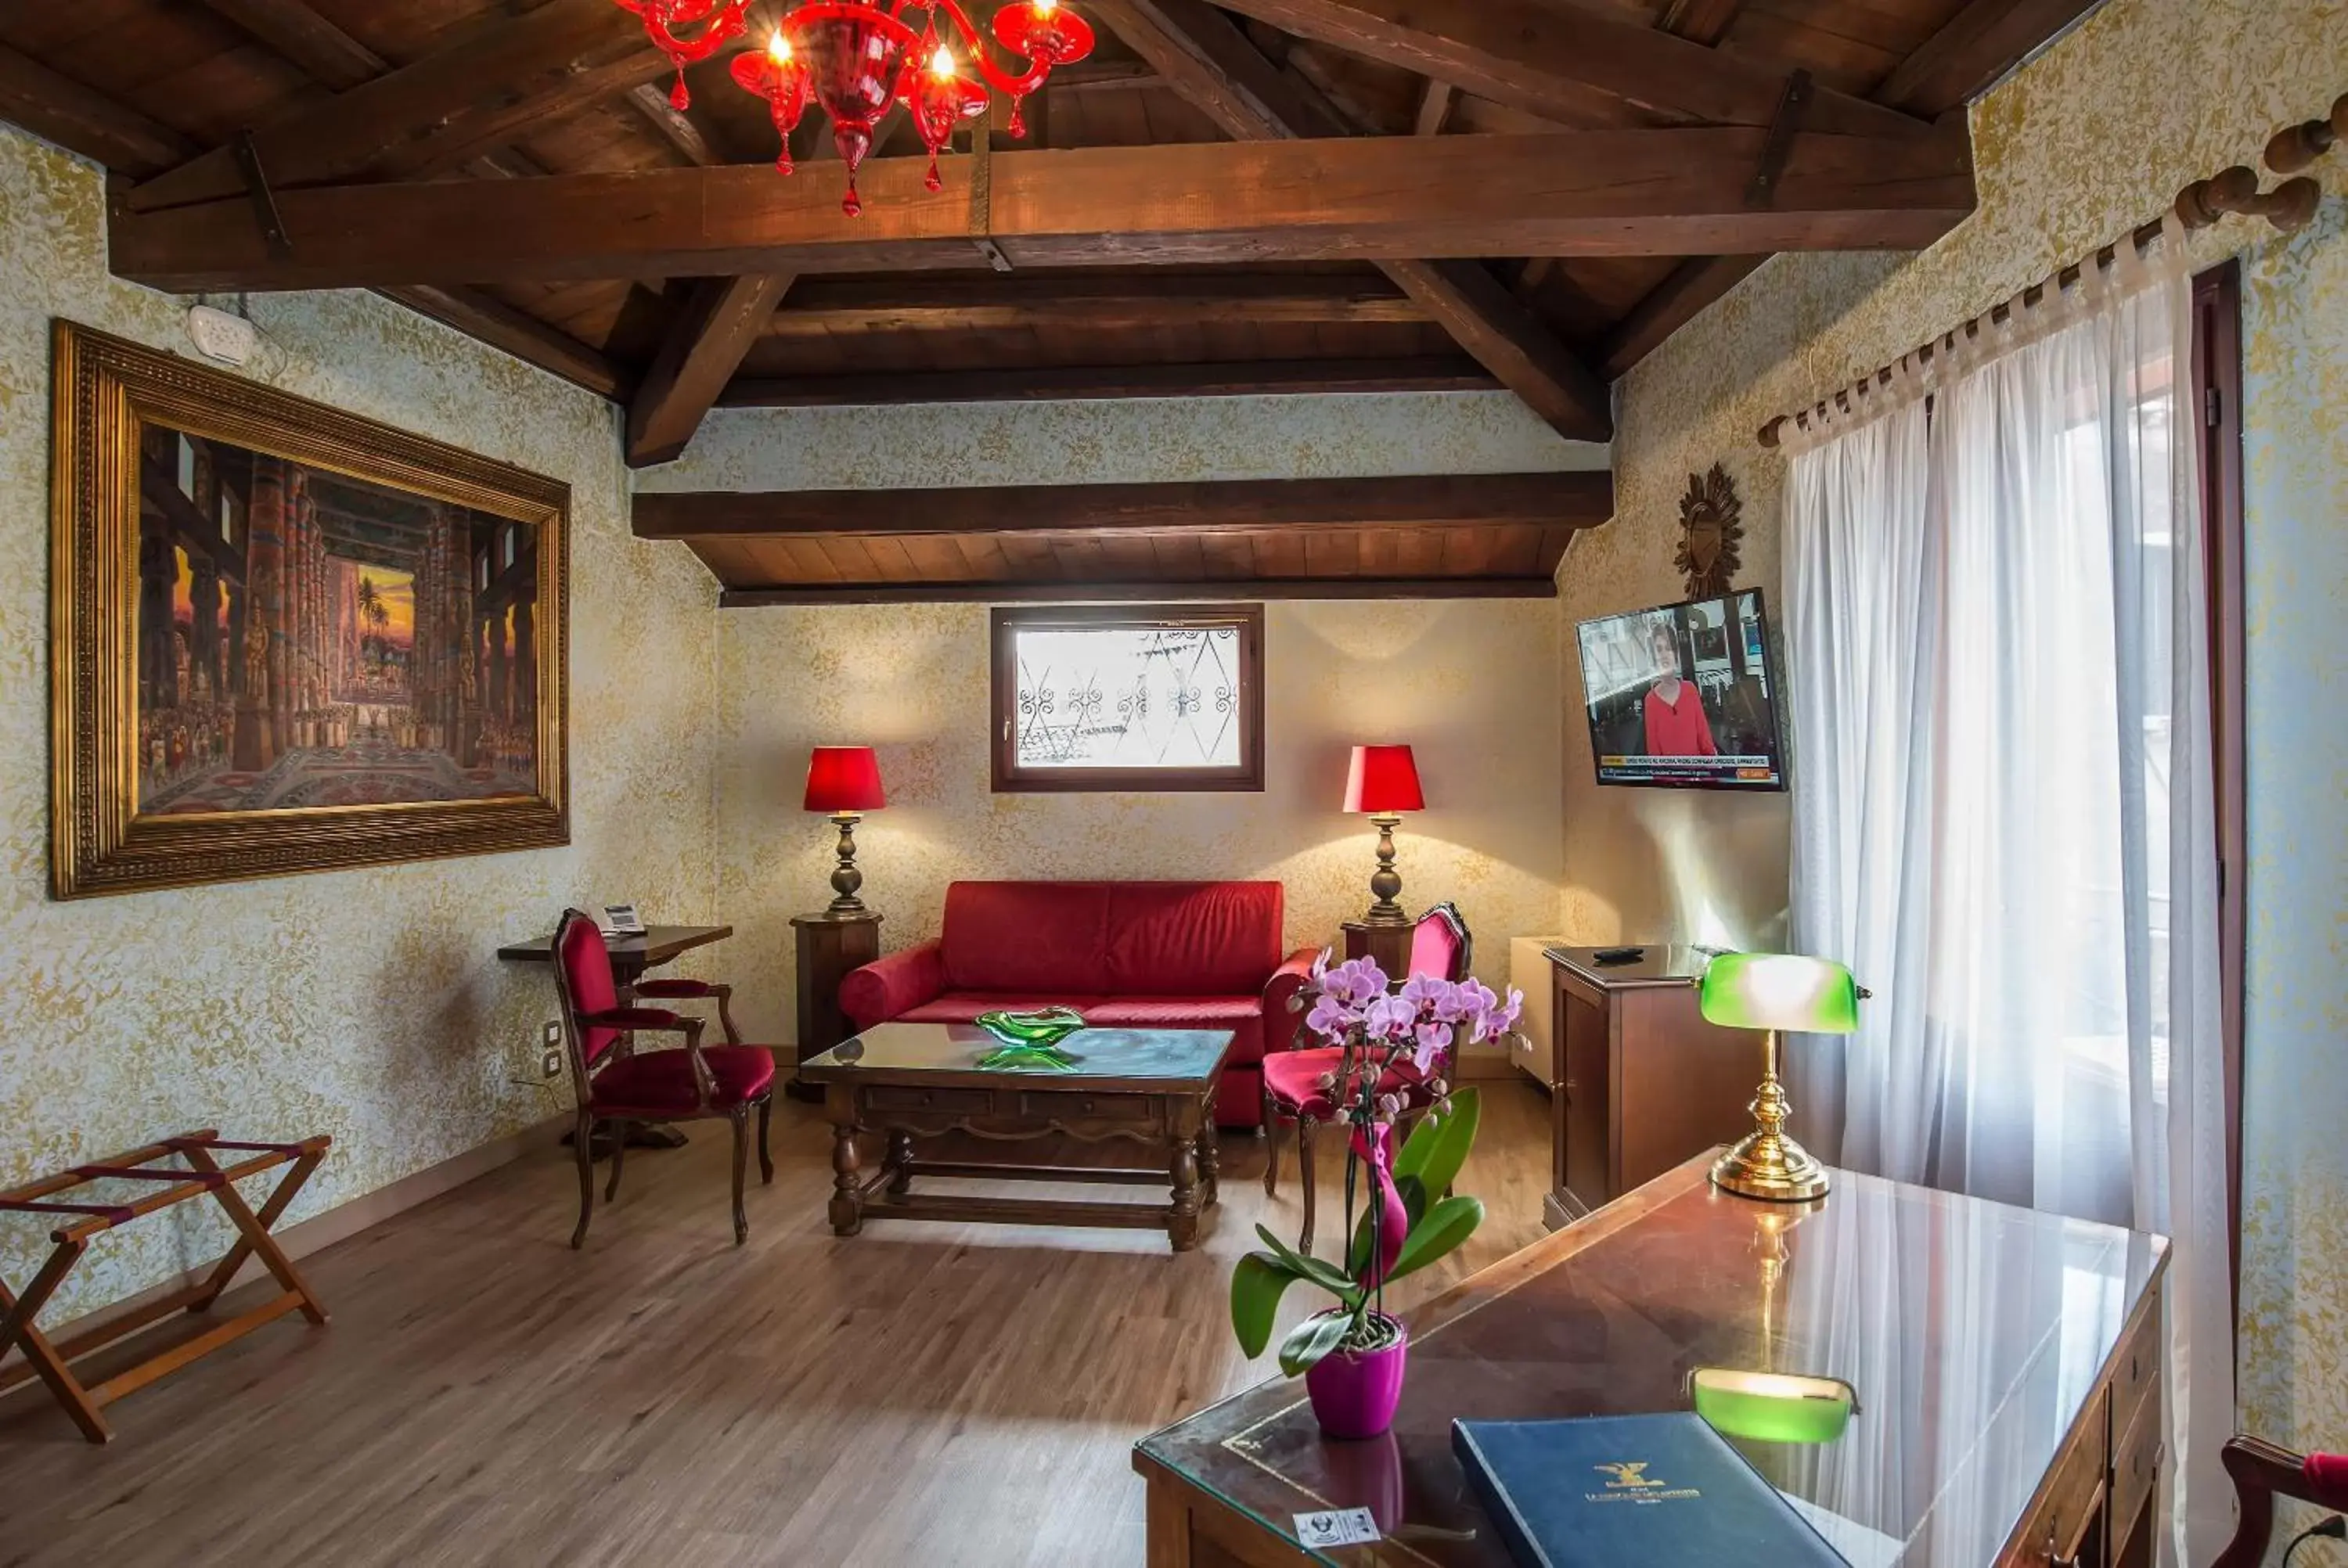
798, 1023, 1233, 1091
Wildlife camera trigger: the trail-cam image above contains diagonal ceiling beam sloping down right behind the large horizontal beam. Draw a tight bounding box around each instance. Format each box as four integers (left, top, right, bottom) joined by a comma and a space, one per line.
1075, 0, 1613, 441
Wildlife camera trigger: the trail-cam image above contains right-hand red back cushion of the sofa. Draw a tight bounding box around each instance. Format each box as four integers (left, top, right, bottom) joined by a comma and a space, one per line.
1101, 883, 1282, 995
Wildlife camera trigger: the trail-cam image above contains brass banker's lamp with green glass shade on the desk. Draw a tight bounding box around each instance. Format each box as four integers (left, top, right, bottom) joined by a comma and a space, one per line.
1695, 953, 1860, 1204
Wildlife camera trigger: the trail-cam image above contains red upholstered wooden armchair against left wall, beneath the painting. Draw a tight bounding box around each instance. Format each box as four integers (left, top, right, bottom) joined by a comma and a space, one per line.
554, 908, 775, 1246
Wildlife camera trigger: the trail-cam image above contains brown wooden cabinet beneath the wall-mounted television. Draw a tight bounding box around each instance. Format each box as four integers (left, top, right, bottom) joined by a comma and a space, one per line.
1545, 946, 1761, 1225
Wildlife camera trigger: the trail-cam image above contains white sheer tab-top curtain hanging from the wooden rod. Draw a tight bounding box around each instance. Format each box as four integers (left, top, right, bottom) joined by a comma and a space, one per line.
1787, 244, 2233, 1563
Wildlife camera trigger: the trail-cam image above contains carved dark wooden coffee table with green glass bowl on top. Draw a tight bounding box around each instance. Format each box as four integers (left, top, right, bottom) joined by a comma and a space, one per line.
798, 1023, 1230, 1251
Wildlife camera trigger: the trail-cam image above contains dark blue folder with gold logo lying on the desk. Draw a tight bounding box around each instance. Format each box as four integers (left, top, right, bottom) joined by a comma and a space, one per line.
1451, 1411, 1848, 1568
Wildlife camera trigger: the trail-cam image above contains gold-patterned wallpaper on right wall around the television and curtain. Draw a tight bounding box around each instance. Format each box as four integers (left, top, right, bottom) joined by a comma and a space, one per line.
1587, 0, 2348, 1502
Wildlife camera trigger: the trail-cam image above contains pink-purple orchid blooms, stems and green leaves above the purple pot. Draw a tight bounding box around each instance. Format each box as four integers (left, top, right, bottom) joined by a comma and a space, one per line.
1230, 953, 1524, 1378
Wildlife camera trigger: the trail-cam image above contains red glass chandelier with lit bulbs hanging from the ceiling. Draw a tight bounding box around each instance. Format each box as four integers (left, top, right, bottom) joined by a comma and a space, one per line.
615, 0, 1092, 218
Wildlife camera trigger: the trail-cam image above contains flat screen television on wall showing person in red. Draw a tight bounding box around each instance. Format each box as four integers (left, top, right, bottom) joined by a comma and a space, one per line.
1578, 589, 1784, 791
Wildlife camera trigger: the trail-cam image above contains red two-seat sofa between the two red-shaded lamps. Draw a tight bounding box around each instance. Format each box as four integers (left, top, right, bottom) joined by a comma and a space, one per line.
841, 883, 1315, 1127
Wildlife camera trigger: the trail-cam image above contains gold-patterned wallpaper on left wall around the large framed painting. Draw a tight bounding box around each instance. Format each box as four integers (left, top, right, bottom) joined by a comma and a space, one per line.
0, 127, 716, 1324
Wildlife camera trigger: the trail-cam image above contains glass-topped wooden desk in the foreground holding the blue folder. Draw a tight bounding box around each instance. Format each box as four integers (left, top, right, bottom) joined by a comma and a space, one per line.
1134, 1150, 2167, 1568
